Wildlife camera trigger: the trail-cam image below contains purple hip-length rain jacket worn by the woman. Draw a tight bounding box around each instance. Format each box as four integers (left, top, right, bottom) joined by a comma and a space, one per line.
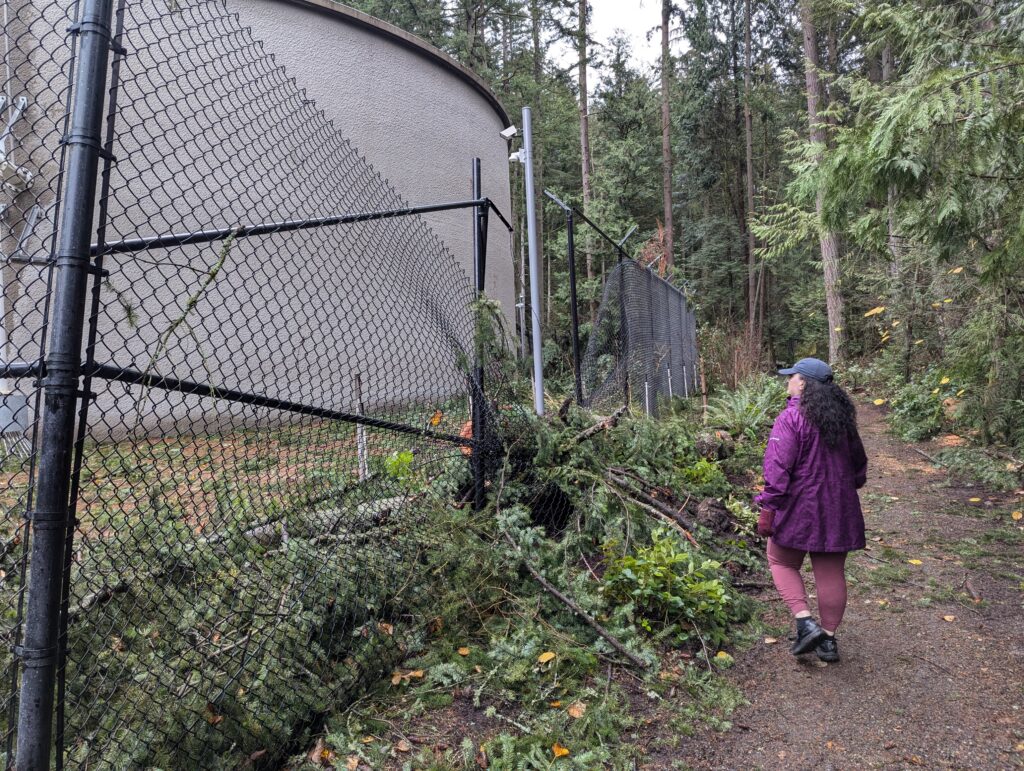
754, 397, 867, 552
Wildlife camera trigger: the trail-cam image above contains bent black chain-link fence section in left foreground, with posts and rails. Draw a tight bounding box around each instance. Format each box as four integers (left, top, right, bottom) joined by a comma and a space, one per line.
0, 0, 512, 769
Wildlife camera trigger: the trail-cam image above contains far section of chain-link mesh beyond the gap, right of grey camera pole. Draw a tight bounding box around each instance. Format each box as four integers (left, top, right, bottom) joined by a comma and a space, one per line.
581, 259, 697, 415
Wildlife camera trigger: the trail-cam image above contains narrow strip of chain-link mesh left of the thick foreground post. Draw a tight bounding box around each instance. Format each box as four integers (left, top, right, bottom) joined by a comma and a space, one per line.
0, 0, 81, 759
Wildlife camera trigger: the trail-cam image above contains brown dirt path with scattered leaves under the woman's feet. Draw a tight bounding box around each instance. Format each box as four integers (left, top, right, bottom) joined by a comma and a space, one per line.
679, 405, 1024, 769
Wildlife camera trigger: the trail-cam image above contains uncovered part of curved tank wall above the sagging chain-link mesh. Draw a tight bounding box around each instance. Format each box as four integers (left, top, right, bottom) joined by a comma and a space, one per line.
227, 0, 515, 309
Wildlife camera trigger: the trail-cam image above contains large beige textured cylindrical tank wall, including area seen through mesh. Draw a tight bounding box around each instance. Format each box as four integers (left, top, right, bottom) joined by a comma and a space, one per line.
4, 0, 514, 440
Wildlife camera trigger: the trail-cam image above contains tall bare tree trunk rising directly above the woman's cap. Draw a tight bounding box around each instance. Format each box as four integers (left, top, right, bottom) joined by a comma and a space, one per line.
800, 0, 845, 363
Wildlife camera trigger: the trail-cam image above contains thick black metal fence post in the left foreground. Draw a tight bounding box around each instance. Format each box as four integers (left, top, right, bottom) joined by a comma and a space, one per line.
14, 0, 114, 771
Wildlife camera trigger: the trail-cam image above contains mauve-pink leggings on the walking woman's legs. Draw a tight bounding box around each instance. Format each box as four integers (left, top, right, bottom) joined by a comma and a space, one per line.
768, 539, 846, 632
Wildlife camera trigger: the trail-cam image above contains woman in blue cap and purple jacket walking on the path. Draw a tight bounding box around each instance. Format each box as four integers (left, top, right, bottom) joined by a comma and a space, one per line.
754, 358, 867, 661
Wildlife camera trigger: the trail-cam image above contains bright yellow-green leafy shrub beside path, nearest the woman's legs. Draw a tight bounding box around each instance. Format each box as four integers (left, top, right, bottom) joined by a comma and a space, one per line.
604, 527, 735, 648
